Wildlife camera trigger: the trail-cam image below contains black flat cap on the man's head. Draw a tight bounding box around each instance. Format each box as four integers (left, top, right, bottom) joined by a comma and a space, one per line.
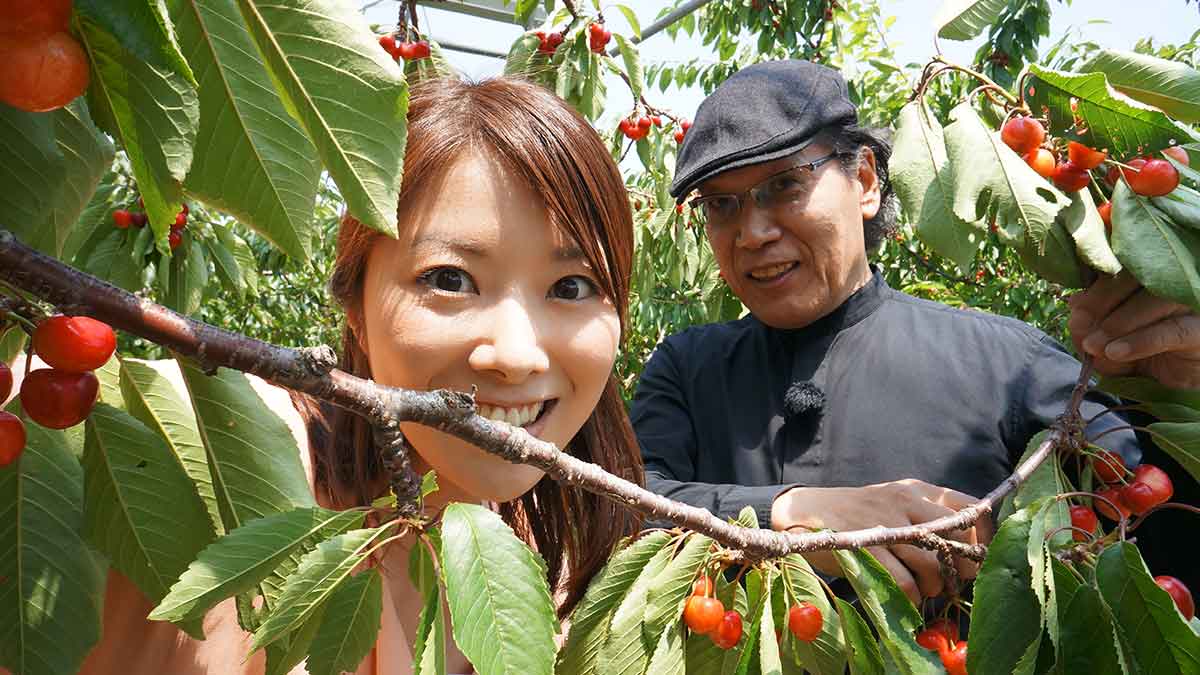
671, 60, 858, 201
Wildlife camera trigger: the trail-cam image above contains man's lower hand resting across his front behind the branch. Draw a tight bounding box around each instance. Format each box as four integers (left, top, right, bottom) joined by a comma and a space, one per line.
770, 479, 992, 605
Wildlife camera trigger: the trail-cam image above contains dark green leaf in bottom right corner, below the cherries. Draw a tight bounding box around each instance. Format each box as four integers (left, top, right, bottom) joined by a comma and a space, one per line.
1099, 542, 1200, 674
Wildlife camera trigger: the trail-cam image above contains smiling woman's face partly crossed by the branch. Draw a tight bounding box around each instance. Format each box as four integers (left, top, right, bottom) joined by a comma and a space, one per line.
361, 154, 620, 502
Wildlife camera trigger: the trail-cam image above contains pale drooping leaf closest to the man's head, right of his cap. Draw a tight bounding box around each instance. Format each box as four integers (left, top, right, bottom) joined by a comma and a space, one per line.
890, 101, 984, 271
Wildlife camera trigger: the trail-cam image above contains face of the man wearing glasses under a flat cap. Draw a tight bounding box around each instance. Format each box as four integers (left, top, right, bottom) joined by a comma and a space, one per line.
700, 143, 880, 328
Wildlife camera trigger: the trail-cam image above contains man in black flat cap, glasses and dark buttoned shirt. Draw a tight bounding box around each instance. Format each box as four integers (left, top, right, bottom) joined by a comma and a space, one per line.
632, 61, 1200, 599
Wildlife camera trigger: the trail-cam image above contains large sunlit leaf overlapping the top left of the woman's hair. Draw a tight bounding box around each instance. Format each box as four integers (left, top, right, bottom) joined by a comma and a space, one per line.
238, 0, 408, 237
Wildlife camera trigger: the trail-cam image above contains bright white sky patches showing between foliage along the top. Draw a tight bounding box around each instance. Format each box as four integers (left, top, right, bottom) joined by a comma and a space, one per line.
360, 0, 1200, 125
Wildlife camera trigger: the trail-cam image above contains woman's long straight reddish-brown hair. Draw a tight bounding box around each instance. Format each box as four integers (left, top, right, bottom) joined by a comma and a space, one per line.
296, 78, 642, 616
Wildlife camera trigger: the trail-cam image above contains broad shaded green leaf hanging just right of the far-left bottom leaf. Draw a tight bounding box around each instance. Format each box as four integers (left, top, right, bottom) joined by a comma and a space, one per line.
83, 404, 216, 639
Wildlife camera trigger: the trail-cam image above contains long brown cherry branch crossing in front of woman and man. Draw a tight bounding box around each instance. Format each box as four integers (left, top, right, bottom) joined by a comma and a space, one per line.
0, 229, 1092, 560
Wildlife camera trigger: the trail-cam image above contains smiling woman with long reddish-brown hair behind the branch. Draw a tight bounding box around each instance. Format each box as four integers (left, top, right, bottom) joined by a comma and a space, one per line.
16, 79, 642, 675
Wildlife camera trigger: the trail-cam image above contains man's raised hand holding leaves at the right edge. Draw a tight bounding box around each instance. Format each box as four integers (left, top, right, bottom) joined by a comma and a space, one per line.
1067, 271, 1200, 389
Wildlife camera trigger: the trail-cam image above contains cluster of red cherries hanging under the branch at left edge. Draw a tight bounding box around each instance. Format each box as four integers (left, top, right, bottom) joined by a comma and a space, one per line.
0, 315, 116, 466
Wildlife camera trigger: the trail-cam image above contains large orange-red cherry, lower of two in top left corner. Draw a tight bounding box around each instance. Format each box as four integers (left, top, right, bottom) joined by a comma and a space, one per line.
0, 32, 89, 113
